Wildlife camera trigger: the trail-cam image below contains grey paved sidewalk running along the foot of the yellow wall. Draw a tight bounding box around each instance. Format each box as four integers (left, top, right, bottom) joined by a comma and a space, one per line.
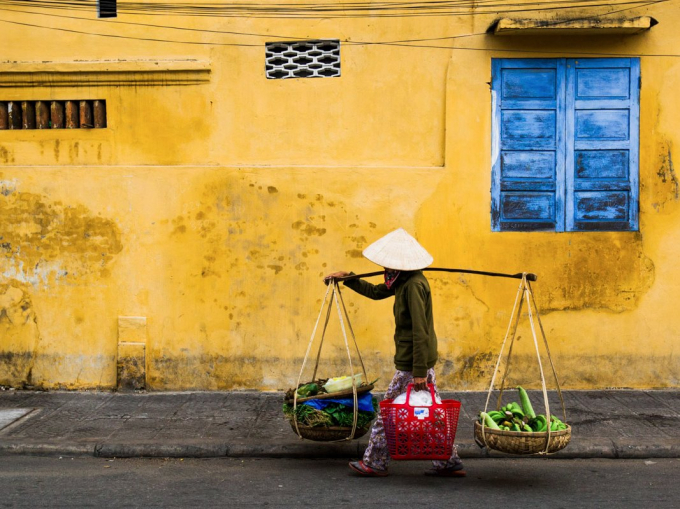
0, 390, 680, 458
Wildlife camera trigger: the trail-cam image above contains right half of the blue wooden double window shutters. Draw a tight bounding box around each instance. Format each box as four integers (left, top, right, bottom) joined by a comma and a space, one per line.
566, 58, 640, 231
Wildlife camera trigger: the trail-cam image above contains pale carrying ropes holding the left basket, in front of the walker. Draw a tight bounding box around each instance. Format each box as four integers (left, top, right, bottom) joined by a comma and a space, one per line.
293, 280, 368, 442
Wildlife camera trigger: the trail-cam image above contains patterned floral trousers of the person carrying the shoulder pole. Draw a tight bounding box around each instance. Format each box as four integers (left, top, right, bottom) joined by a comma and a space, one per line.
364, 368, 462, 470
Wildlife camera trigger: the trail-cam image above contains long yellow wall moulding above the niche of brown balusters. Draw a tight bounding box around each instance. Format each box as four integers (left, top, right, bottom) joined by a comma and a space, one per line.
0, 60, 211, 88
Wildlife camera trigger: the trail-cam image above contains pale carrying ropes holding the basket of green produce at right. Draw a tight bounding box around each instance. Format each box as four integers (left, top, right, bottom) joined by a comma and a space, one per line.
481, 273, 567, 455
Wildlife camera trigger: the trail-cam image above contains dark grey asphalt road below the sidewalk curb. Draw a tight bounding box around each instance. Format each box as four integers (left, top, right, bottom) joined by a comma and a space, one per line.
0, 456, 680, 509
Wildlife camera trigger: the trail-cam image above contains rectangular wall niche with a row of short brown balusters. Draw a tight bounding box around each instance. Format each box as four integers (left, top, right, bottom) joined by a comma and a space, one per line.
0, 99, 106, 130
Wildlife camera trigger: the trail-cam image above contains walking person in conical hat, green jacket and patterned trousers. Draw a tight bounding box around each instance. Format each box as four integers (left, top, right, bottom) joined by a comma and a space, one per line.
324, 228, 465, 477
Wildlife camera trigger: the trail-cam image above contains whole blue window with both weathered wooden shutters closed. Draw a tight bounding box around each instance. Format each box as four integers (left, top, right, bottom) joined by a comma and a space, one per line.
491, 58, 640, 232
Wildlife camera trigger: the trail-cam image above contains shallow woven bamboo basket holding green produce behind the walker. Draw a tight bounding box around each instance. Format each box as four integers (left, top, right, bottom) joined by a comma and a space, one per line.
475, 421, 571, 454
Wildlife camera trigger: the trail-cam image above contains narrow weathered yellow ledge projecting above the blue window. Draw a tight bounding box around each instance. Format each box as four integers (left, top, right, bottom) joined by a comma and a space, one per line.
487, 16, 659, 35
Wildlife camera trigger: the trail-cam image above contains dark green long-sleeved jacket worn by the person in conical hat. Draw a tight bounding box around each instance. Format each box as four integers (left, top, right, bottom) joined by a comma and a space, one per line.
345, 270, 437, 377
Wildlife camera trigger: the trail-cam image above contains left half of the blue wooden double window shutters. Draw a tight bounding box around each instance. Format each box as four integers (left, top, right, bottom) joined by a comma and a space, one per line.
491, 59, 565, 231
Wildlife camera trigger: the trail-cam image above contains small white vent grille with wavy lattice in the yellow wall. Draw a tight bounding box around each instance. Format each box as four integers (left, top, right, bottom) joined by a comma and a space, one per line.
265, 39, 340, 80
